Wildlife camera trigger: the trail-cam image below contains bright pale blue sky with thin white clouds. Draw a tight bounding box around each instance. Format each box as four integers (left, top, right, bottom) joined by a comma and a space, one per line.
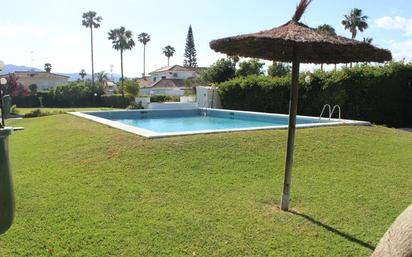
0, 0, 412, 77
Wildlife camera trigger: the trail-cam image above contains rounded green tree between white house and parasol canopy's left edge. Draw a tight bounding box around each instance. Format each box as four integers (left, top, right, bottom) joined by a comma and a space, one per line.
201, 58, 236, 83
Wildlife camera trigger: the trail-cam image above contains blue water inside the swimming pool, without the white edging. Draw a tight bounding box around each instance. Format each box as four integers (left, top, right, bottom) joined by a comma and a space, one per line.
86, 109, 332, 133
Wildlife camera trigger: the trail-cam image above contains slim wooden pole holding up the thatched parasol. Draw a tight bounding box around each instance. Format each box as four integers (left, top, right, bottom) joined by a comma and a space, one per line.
280, 45, 300, 211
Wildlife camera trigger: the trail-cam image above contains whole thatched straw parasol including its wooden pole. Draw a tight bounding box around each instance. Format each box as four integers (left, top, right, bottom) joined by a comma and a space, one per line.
210, 0, 392, 210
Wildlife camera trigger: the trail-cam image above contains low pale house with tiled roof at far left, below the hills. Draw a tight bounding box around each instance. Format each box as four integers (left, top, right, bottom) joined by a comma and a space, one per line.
1, 71, 69, 90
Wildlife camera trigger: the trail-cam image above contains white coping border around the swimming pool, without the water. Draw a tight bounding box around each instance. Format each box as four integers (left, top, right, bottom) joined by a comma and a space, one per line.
69, 108, 371, 139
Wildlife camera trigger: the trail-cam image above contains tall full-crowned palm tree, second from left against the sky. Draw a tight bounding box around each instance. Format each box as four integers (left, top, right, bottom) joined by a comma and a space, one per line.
109, 26, 135, 99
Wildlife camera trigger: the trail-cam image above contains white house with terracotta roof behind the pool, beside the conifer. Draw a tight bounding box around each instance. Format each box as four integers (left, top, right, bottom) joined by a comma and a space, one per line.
139, 65, 204, 96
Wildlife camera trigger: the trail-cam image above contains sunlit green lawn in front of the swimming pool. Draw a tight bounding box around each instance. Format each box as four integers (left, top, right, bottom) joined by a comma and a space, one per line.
0, 114, 412, 257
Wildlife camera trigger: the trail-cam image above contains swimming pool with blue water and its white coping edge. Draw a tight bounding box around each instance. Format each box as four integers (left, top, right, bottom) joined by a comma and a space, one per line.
71, 108, 369, 138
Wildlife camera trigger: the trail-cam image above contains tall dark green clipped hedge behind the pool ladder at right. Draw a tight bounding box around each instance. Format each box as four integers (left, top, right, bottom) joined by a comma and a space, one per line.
218, 62, 412, 127
